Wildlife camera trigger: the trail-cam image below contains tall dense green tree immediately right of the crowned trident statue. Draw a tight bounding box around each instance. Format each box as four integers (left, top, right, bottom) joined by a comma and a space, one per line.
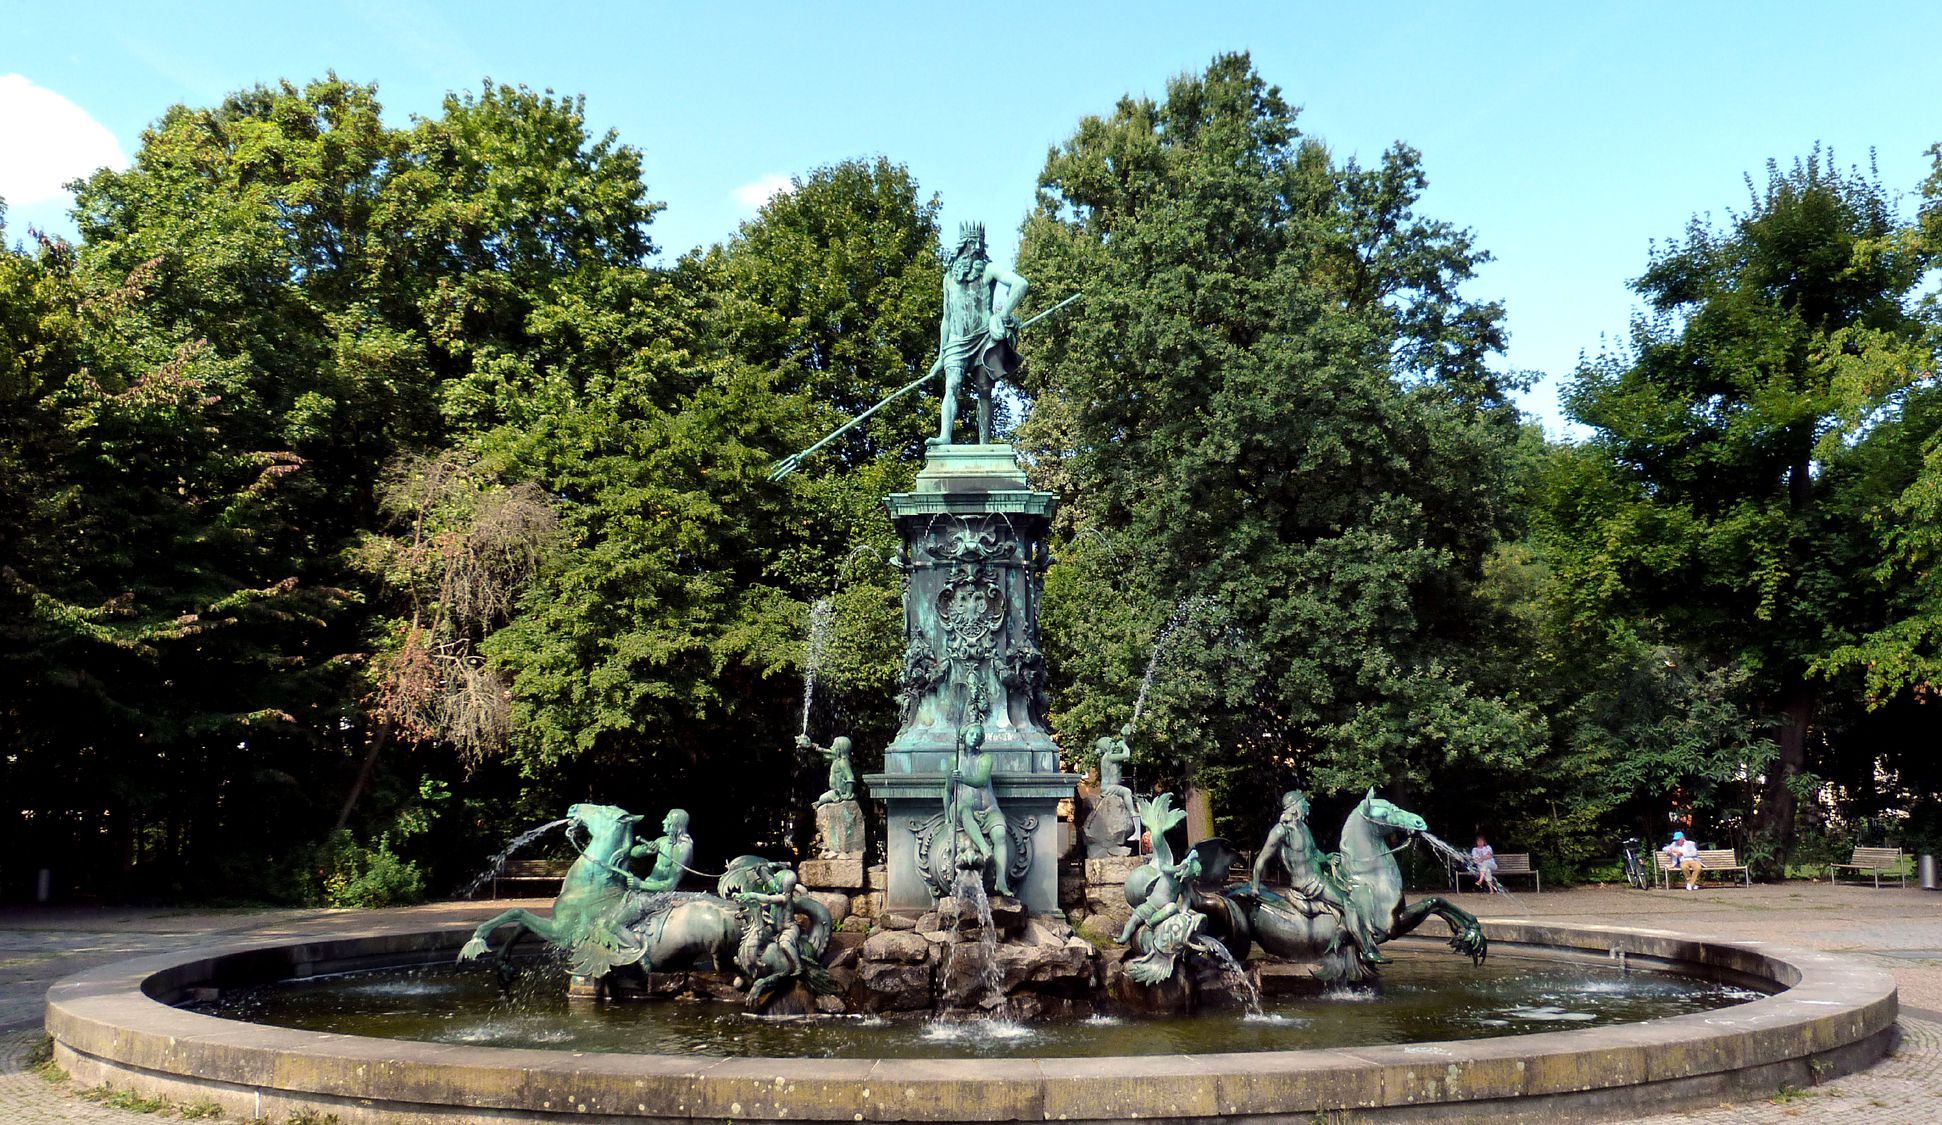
1020, 54, 1540, 835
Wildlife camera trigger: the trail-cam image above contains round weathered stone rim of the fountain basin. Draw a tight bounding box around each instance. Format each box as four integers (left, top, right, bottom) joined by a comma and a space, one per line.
47, 921, 1897, 1125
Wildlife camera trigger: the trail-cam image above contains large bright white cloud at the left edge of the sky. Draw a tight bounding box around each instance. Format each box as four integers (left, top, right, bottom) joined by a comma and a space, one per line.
0, 74, 128, 208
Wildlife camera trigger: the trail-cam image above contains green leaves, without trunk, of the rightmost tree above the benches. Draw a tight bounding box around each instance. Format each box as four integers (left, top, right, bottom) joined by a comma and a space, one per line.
1542, 152, 1934, 851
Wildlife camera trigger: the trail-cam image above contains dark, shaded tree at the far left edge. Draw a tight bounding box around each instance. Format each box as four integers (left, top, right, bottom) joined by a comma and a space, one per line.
0, 226, 350, 894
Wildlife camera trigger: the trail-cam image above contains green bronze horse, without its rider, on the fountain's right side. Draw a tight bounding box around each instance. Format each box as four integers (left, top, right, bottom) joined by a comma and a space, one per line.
1225, 789, 1490, 983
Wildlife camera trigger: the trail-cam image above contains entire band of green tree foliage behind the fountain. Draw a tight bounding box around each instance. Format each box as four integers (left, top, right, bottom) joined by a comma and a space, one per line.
0, 68, 1942, 905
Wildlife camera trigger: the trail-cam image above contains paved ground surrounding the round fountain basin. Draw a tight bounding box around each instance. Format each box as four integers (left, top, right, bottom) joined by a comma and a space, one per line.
0, 884, 1942, 1125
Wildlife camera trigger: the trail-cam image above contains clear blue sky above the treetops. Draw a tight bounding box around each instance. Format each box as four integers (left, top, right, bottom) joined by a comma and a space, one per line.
0, 0, 1942, 433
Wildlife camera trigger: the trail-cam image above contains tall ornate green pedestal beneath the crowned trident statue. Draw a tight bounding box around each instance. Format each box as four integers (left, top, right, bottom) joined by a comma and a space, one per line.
866, 445, 1076, 913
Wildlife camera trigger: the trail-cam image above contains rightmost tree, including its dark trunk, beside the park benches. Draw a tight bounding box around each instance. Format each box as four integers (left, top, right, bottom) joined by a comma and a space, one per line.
1561, 150, 1921, 866
